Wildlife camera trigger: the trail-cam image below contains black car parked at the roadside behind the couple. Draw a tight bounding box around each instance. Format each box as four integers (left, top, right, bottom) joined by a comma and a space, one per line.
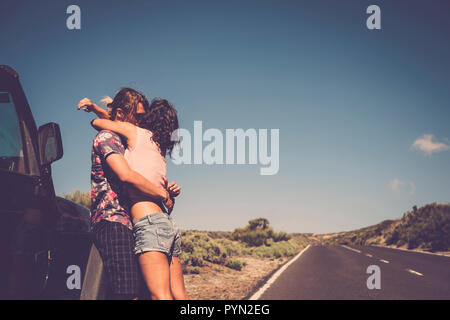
0, 65, 102, 299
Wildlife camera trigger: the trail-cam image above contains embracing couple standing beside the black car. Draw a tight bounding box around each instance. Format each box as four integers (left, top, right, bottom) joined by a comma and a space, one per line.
77, 88, 188, 300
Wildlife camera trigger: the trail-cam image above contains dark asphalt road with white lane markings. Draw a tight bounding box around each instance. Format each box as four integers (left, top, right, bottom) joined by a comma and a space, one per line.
259, 246, 450, 300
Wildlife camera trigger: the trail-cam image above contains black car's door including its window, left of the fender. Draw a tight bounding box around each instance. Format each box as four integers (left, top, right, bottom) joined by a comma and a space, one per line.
0, 65, 56, 298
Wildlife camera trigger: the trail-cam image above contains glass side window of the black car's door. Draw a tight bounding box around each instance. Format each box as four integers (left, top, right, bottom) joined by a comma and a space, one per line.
0, 91, 25, 173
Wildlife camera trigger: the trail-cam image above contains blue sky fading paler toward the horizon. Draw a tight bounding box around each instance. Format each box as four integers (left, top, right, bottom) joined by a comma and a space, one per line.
0, 0, 450, 233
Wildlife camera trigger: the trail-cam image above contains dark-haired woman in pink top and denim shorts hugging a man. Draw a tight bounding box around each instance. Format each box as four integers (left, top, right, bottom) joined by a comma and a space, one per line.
79, 91, 188, 300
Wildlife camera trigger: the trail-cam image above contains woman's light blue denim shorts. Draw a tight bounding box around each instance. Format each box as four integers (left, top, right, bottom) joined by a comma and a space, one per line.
133, 212, 181, 257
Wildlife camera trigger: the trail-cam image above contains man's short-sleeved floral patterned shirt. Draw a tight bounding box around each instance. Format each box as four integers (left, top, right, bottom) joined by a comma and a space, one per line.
91, 130, 132, 229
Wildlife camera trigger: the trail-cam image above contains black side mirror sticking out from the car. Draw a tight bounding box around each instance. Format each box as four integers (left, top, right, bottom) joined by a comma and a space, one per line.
38, 122, 63, 166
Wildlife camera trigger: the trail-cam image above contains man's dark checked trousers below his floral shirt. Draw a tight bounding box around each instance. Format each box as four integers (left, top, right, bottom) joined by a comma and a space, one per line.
93, 220, 139, 300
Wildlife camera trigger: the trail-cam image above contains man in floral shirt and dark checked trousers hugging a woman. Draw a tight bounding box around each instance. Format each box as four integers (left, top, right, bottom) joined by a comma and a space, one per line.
78, 88, 173, 300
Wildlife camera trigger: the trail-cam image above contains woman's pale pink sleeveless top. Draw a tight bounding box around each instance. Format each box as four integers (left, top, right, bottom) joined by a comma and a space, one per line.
125, 127, 166, 188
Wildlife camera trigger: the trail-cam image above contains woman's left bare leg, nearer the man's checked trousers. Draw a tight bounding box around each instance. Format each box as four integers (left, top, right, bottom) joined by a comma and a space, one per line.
139, 251, 173, 300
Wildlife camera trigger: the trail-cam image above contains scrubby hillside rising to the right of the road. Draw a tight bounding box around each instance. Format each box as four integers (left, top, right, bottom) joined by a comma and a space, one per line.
321, 203, 450, 251
